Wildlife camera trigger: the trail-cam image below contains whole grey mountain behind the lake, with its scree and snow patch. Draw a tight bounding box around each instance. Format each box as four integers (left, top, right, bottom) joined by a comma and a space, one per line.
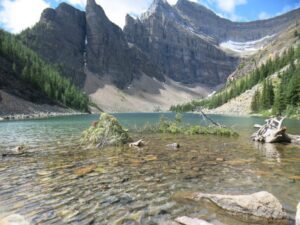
18, 0, 300, 111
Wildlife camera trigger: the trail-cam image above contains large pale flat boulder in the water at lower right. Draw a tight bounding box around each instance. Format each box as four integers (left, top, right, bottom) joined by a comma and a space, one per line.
187, 191, 288, 220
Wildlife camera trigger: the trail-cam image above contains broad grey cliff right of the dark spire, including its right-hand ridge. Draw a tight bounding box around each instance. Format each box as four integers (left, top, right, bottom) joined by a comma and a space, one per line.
124, 0, 300, 86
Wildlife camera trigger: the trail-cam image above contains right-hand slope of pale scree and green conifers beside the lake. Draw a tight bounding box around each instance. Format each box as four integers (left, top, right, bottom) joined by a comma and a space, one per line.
172, 21, 300, 118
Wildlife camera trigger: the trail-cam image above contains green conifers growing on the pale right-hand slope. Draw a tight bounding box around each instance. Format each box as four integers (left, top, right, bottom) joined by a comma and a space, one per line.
170, 45, 300, 113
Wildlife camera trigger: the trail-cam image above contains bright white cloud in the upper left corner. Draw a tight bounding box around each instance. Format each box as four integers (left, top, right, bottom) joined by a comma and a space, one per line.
0, 0, 49, 33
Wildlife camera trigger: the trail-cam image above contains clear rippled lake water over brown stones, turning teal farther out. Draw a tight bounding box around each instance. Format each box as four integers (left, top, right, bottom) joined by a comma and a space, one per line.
0, 113, 300, 225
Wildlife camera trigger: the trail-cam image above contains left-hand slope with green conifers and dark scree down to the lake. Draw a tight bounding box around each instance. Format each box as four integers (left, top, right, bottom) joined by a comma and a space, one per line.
0, 30, 89, 117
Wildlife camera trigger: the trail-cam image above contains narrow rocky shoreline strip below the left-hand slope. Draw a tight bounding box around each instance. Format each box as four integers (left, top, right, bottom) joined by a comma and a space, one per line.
0, 111, 89, 122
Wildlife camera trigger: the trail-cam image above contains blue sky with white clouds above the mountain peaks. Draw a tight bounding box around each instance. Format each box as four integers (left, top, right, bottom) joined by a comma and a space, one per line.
0, 0, 300, 33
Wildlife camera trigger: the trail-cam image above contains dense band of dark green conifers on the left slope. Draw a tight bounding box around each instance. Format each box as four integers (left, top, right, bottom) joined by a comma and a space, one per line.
0, 30, 89, 111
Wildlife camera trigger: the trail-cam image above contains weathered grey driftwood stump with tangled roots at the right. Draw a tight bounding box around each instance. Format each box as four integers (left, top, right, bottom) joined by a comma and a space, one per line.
251, 117, 292, 143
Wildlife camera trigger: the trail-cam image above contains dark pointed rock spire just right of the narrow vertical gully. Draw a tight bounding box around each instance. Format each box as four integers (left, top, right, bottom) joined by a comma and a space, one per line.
86, 0, 164, 88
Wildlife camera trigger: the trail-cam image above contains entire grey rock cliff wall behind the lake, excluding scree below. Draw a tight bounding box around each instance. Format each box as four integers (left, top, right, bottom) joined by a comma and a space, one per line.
20, 0, 300, 88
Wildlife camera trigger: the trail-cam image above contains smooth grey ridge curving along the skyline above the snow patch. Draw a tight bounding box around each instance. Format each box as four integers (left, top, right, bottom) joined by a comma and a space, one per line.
174, 0, 300, 42
